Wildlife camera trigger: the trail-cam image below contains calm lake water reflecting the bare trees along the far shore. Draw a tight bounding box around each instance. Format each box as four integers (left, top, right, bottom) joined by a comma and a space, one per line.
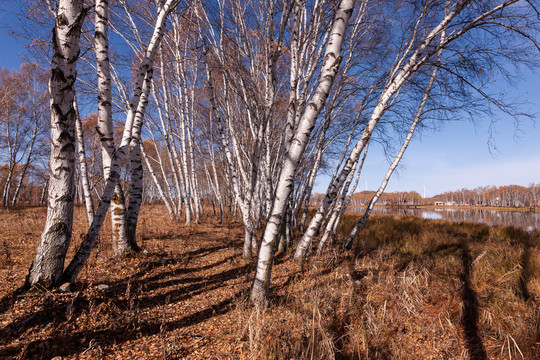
348, 206, 540, 230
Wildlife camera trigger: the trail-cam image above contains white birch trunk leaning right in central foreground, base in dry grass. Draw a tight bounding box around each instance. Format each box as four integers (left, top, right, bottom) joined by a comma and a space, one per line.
250, 0, 354, 306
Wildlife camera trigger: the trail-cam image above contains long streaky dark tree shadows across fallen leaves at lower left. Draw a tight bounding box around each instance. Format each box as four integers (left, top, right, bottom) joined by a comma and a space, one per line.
0, 240, 253, 358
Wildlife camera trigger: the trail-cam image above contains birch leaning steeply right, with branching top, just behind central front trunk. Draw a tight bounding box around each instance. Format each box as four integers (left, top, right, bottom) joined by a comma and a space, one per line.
295, 0, 540, 260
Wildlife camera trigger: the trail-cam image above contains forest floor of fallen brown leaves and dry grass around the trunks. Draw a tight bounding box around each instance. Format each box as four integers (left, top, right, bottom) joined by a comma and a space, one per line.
0, 206, 540, 360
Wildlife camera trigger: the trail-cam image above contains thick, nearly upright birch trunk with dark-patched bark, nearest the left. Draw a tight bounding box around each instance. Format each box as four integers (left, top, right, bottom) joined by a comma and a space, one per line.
25, 0, 88, 288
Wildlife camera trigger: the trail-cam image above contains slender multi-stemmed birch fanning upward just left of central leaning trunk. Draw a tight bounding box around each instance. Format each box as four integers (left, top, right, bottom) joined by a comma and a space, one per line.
197, 1, 290, 258
